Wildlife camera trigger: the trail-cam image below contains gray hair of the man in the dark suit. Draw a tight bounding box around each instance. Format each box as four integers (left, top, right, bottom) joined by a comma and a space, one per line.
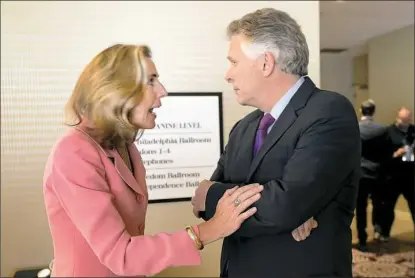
227, 8, 309, 76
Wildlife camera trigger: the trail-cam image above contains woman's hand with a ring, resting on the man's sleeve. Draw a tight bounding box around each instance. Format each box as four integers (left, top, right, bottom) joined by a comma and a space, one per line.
199, 184, 264, 245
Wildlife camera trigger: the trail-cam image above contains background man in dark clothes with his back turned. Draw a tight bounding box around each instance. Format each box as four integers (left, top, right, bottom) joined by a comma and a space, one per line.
356, 100, 391, 252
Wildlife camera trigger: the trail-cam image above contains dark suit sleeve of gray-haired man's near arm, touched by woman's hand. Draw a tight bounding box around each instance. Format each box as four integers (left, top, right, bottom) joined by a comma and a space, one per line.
206, 97, 360, 237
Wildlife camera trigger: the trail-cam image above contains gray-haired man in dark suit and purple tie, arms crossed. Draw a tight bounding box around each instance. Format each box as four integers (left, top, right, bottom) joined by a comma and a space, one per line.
192, 8, 360, 278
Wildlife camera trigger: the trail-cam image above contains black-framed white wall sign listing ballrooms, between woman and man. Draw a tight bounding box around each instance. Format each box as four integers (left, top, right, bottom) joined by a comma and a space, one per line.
136, 93, 223, 203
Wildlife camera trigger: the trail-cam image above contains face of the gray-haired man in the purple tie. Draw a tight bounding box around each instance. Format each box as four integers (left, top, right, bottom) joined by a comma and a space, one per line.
225, 32, 263, 107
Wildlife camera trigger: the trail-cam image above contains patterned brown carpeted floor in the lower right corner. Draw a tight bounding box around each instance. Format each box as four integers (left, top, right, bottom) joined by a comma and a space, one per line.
353, 233, 415, 277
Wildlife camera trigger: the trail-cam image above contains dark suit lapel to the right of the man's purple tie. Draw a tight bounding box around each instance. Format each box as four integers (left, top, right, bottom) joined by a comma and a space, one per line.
246, 77, 316, 182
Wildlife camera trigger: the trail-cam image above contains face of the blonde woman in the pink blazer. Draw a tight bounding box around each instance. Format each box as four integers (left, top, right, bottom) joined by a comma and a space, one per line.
131, 58, 167, 129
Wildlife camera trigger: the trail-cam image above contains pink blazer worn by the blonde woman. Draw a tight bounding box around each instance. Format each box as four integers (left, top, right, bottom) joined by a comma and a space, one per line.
43, 129, 201, 277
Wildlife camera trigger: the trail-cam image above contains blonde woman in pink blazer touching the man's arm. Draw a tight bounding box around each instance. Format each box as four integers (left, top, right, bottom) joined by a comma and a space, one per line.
44, 44, 263, 277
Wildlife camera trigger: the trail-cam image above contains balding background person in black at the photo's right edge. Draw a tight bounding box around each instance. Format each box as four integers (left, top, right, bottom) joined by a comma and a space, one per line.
377, 107, 415, 241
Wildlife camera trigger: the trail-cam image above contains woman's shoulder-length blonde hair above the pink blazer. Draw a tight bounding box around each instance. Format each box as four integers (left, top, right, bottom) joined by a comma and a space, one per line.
65, 44, 151, 148
